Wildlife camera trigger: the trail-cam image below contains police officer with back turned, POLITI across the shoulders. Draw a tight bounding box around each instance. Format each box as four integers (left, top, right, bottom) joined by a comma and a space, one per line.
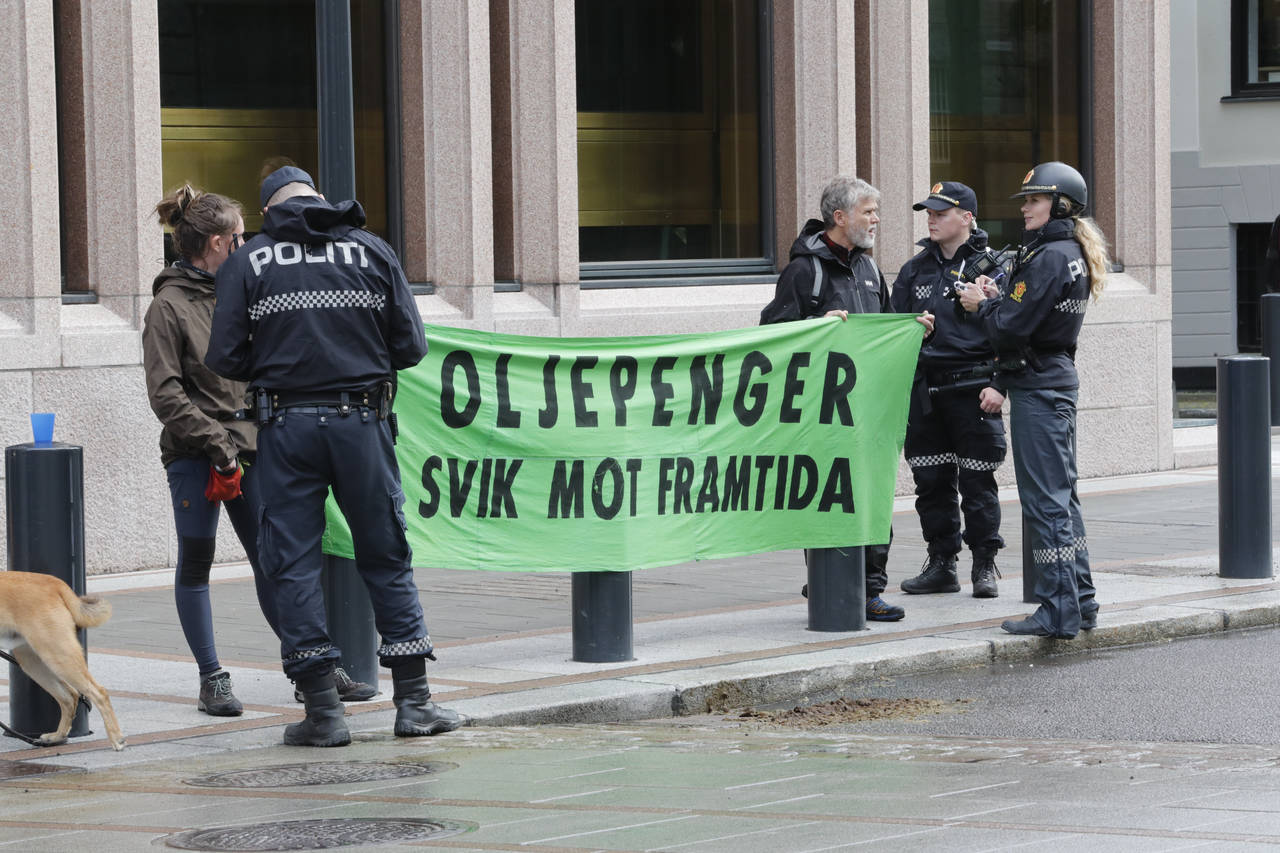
205, 167, 462, 747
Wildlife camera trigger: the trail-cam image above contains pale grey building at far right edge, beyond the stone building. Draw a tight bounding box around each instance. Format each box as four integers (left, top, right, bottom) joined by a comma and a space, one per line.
1170, 0, 1280, 387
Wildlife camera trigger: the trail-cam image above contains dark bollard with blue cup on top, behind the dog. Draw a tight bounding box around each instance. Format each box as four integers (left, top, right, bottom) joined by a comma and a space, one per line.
4, 442, 92, 738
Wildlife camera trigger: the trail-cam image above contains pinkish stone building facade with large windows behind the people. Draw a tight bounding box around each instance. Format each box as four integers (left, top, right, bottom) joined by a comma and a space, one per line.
0, 0, 1172, 573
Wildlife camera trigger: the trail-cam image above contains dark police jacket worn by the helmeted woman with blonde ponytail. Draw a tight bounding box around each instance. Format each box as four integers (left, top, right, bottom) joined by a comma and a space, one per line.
977, 219, 1089, 389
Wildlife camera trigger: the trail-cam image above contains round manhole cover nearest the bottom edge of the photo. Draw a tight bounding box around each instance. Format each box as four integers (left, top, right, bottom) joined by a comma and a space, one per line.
164, 817, 475, 850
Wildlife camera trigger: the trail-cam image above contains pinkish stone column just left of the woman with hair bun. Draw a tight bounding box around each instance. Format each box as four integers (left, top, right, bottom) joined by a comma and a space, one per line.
74, 0, 164, 326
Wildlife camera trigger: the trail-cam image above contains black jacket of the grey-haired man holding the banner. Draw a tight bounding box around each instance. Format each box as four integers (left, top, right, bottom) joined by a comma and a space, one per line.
760, 219, 888, 325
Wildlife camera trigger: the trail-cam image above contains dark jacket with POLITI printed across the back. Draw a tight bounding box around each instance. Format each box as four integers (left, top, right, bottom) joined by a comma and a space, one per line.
205, 196, 426, 392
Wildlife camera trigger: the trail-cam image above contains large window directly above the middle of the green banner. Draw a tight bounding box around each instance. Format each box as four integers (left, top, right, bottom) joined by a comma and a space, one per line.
576, 0, 772, 279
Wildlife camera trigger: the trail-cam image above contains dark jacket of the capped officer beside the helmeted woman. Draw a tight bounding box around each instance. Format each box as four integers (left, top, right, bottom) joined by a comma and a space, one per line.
891, 228, 995, 366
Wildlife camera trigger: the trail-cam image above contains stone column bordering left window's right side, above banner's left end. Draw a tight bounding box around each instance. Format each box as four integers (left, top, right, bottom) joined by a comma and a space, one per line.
401, 0, 493, 322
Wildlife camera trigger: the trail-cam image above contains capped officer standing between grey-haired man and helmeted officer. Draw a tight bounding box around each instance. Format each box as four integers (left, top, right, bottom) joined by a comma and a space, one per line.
892, 181, 1005, 598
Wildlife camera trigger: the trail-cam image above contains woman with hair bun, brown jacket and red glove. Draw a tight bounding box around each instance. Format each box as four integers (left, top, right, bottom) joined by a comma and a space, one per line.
142, 184, 376, 716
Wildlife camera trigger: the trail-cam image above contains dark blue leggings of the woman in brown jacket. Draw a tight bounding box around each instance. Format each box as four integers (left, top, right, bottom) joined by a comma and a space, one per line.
165, 459, 279, 678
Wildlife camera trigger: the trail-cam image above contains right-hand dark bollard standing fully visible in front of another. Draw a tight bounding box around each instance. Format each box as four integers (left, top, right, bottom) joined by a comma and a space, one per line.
1217, 355, 1272, 578
